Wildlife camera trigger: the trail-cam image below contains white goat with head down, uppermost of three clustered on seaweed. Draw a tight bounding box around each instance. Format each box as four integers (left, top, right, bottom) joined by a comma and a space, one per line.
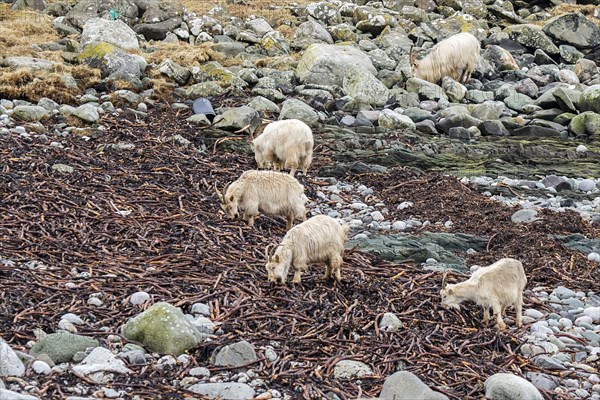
252, 119, 314, 175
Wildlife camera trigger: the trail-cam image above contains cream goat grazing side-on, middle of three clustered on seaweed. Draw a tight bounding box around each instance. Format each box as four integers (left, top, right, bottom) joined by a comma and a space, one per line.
215, 170, 308, 229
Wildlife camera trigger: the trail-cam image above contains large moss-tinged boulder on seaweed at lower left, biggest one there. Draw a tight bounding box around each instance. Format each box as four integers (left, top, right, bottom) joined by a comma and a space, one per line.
122, 302, 204, 357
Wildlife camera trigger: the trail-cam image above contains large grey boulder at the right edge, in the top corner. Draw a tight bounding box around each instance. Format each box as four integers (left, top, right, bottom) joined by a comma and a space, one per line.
543, 12, 600, 49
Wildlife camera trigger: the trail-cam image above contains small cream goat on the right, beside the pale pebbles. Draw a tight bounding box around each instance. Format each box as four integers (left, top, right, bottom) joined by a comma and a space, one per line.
440, 258, 527, 330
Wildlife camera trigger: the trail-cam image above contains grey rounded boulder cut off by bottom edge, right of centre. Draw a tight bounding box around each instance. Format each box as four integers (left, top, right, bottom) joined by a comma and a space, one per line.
379, 371, 448, 400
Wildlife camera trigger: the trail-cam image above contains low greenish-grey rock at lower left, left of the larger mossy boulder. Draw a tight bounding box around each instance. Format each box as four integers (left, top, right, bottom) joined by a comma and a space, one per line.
29, 331, 100, 364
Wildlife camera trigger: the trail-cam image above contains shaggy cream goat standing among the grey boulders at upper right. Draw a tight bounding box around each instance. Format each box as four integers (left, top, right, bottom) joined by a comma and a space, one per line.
409, 32, 480, 83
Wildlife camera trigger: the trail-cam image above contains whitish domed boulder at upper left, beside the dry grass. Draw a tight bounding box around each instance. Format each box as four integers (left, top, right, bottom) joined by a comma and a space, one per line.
80, 18, 140, 50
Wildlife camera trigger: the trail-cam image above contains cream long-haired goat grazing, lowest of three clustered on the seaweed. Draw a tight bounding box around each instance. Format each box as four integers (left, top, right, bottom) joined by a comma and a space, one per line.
265, 215, 350, 284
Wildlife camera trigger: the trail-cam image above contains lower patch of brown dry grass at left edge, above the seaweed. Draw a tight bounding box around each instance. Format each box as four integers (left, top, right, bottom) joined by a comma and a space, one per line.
0, 65, 100, 104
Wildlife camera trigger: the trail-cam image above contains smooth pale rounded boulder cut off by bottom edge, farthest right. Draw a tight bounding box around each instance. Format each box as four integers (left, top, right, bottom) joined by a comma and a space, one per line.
485, 373, 544, 400
